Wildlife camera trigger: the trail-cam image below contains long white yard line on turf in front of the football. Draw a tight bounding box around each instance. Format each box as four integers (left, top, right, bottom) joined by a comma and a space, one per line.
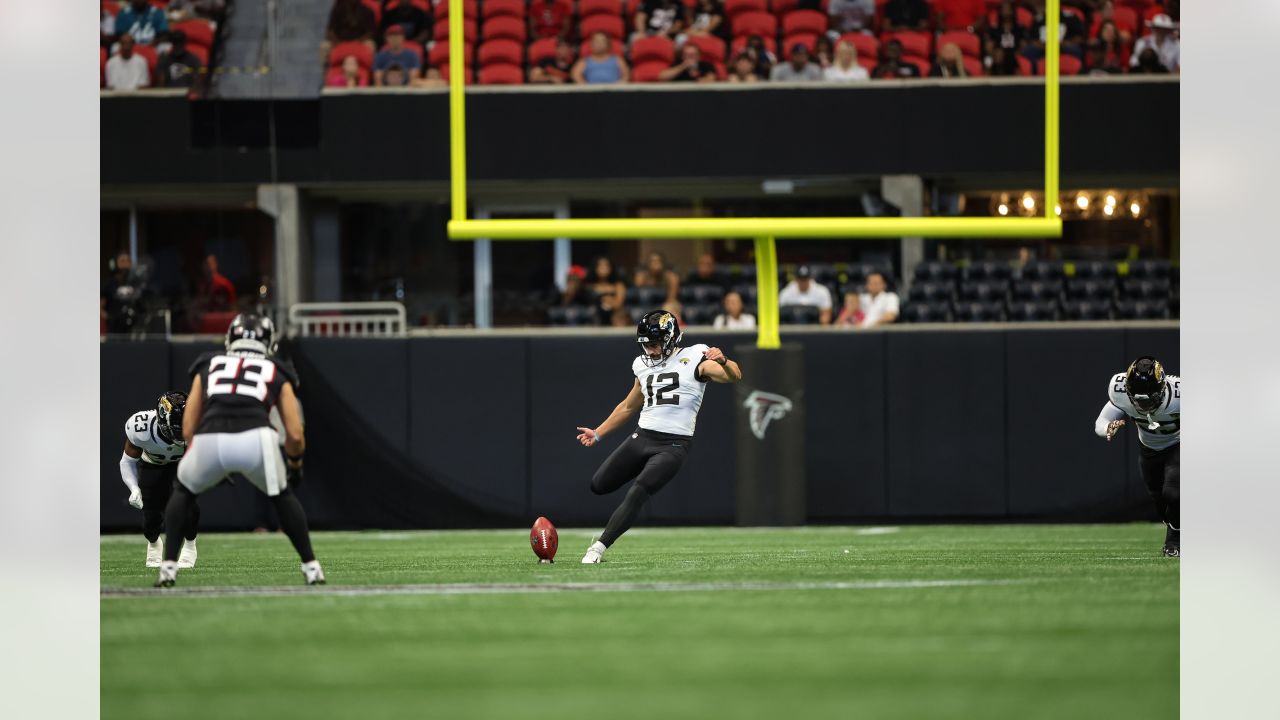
101, 578, 1030, 600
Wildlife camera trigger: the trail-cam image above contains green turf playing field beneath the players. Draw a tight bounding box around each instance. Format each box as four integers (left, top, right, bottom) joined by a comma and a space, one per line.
101, 524, 1178, 720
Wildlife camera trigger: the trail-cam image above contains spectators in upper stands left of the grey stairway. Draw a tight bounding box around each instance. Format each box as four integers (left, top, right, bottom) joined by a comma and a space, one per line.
99, 0, 225, 92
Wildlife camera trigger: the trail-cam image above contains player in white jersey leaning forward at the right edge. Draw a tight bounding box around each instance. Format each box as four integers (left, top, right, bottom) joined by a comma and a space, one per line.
1093, 355, 1183, 557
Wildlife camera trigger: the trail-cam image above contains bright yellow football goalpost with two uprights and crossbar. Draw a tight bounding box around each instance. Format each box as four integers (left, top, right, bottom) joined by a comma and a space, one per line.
448, 0, 1062, 348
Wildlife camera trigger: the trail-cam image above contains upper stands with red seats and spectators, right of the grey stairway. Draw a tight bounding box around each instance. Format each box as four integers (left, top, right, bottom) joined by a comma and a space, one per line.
325, 0, 1179, 87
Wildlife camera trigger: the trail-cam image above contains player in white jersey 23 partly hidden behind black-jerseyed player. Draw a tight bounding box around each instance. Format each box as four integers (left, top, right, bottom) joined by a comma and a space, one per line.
120, 392, 200, 568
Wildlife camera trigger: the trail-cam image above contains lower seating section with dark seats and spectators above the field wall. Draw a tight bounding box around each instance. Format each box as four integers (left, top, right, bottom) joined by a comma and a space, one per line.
548, 252, 1179, 324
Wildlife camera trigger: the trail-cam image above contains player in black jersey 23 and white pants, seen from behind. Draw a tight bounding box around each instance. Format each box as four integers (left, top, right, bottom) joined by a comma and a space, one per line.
156, 314, 325, 588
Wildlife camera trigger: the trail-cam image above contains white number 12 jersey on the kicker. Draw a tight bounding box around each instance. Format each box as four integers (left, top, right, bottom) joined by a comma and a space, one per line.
631, 345, 708, 436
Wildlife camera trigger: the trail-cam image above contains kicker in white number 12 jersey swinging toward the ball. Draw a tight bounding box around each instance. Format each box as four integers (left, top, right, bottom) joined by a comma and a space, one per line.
577, 310, 742, 564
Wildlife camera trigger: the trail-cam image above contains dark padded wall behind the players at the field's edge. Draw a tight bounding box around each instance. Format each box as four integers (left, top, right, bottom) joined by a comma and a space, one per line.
100, 323, 1179, 530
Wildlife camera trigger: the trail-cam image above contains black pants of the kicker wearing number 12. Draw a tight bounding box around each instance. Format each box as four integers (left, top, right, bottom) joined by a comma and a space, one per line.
591, 428, 694, 547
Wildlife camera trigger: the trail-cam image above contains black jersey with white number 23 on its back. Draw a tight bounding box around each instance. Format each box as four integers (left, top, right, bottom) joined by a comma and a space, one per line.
189, 352, 298, 434
